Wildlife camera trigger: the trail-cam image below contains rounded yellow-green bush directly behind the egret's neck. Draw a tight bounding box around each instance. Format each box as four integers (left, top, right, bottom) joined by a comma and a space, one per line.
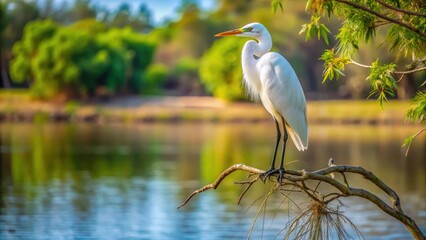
200, 38, 245, 101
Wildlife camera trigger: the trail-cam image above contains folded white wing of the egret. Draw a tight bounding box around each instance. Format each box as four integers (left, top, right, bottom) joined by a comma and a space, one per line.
260, 53, 308, 151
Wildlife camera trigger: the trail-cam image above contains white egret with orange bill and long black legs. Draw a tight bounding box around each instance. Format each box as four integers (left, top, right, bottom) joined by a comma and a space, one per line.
215, 23, 308, 182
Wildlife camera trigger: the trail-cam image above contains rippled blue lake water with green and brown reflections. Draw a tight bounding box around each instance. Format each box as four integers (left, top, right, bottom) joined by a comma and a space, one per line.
0, 122, 426, 239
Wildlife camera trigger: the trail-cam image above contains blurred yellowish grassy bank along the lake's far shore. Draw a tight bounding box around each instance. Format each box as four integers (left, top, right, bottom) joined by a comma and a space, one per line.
0, 91, 416, 124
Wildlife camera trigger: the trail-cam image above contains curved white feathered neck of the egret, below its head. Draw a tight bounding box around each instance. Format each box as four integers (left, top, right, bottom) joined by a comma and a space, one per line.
241, 31, 272, 100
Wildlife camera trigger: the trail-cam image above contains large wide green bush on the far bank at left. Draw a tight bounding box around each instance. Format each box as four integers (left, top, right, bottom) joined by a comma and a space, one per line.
10, 19, 155, 98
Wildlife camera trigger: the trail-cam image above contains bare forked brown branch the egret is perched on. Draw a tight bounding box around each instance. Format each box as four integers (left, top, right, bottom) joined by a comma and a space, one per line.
178, 164, 425, 239
